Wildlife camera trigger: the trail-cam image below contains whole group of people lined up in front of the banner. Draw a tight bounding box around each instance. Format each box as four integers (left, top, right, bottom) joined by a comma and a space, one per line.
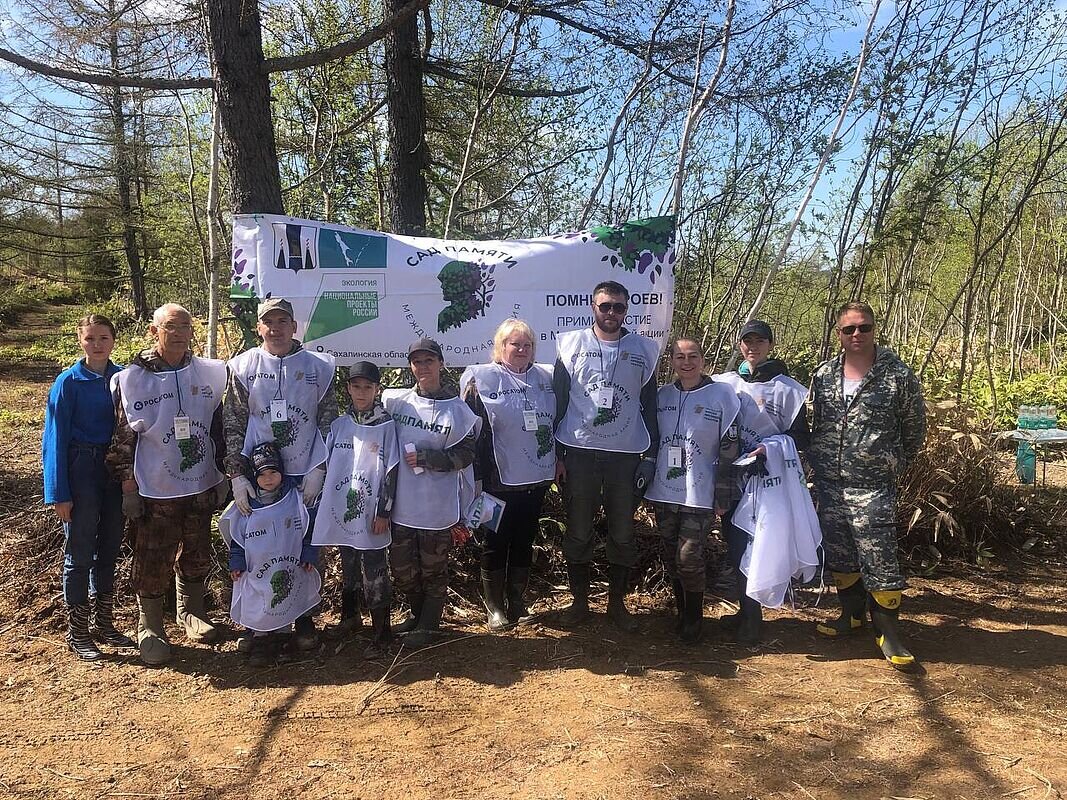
43, 282, 924, 669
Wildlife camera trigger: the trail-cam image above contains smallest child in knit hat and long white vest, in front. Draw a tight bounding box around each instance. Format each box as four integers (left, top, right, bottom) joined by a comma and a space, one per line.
226, 442, 322, 667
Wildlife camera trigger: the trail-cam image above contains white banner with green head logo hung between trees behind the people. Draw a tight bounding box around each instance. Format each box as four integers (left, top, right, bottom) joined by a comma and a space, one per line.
230, 214, 674, 367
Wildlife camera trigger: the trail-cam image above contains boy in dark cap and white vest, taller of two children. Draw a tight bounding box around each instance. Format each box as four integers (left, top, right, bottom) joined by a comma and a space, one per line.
313, 362, 400, 658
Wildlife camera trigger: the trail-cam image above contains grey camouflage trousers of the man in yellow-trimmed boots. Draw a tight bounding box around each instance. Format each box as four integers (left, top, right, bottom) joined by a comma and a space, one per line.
815, 481, 906, 592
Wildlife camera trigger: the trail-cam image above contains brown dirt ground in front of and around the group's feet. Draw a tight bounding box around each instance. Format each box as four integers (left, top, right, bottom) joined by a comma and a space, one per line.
0, 316, 1067, 800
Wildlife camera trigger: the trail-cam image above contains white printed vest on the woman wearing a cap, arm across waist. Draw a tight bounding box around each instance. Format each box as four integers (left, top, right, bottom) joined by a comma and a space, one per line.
382, 389, 481, 530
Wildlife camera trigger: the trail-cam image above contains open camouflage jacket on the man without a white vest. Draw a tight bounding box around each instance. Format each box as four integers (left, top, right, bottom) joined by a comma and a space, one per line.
808, 348, 926, 487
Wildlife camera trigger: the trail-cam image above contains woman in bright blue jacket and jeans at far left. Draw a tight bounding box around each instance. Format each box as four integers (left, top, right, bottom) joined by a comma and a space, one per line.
41, 314, 136, 661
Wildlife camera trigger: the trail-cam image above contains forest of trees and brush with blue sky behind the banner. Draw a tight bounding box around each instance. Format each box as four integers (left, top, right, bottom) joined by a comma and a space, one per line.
0, 0, 1067, 569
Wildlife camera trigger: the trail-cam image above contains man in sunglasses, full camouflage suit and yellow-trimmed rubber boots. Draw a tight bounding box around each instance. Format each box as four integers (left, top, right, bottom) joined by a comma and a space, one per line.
808, 303, 926, 670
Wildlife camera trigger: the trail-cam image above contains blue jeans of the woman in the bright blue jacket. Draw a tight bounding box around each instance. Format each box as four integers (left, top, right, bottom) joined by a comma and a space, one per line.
63, 442, 123, 606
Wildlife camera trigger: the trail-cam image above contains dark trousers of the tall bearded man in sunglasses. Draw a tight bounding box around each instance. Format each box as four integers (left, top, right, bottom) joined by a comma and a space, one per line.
563, 447, 641, 566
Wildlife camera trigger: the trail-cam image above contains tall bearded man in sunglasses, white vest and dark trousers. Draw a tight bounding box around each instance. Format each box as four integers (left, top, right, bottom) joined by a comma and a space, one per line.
553, 281, 659, 633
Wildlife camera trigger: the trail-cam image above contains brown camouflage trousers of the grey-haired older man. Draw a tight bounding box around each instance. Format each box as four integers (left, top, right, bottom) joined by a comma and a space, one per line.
130, 489, 216, 597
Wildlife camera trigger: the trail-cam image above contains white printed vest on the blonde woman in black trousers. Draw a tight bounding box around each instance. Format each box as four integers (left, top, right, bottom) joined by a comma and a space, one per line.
460, 364, 556, 486
